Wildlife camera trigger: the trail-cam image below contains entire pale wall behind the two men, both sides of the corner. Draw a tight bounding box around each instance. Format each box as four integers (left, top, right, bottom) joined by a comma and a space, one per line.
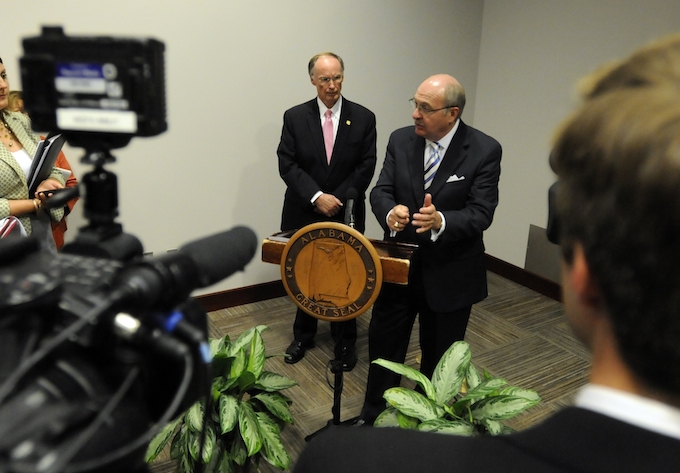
6, 0, 680, 292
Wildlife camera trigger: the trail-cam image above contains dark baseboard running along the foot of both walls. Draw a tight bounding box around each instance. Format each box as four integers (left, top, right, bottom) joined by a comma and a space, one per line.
196, 255, 562, 312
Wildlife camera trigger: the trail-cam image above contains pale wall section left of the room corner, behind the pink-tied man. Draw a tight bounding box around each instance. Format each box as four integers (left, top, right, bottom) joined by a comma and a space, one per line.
0, 0, 483, 292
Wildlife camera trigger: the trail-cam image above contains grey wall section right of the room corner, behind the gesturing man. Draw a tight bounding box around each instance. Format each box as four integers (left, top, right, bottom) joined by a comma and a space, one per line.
475, 0, 680, 267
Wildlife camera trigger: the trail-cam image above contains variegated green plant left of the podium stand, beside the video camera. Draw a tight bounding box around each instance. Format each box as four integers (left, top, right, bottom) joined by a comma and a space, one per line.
146, 325, 297, 473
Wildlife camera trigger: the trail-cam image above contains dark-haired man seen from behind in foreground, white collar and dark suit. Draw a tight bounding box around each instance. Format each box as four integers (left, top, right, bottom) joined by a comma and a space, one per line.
295, 35, 680, 473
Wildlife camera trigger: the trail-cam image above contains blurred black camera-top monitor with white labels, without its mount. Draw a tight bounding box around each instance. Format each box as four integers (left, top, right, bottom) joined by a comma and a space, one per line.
20, 26, 168, 149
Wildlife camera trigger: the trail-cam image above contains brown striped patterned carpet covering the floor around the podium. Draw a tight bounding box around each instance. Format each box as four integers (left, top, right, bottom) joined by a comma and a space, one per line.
152, 272, 589, 473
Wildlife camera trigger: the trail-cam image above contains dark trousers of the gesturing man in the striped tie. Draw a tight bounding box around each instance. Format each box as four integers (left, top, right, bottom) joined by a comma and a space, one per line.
361, 281, 472, 422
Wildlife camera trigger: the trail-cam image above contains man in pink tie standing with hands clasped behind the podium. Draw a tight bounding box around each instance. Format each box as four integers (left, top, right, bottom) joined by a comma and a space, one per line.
277, 52, 376, 371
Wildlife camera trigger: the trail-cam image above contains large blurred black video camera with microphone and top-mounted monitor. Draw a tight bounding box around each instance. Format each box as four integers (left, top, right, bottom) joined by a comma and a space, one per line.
0, 28, 258, 473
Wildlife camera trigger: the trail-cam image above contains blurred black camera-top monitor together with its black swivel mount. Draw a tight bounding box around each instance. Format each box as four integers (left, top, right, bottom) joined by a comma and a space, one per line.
20, 26, 167, 261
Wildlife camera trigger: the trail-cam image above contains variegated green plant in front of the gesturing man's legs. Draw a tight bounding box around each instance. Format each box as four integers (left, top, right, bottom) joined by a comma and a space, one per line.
373, 341, 541, 435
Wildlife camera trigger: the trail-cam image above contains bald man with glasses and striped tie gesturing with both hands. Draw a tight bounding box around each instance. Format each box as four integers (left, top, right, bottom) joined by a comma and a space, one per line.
360, 74, 502, 424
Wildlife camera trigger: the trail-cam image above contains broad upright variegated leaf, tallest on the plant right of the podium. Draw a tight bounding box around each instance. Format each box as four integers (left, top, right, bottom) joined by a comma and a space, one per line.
432, 340, 472, 404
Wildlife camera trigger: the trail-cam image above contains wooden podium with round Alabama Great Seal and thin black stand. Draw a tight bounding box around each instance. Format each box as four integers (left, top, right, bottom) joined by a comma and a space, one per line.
262, 222, 418, 434
